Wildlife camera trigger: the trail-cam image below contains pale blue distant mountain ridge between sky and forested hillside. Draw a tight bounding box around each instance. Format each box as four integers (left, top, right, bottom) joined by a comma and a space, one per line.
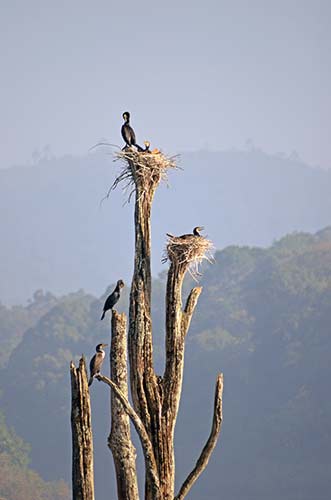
0, 151, 331, 304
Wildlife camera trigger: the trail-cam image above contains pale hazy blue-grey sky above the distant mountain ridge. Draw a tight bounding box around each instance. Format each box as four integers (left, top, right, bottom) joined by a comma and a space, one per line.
0, 0, 331, 167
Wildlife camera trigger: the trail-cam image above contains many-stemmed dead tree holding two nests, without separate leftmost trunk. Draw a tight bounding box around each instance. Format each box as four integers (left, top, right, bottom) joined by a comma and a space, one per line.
71, 149, 223, 500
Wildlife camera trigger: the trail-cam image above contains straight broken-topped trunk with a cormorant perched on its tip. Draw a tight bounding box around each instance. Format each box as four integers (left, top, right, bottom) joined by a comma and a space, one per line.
108, 309, 139, 500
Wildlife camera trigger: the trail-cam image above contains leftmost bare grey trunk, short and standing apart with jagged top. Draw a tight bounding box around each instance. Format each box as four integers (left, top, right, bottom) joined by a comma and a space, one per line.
70, 358, 94, 500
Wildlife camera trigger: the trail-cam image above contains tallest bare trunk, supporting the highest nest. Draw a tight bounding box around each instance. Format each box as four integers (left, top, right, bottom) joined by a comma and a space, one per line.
129, 162, 163, 500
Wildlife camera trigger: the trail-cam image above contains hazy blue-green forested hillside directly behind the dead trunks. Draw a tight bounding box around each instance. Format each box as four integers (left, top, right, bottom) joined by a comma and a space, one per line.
0, 227, 331, 500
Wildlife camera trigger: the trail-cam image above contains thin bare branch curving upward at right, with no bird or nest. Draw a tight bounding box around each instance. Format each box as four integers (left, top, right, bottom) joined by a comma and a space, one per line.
175, 373, 223, 500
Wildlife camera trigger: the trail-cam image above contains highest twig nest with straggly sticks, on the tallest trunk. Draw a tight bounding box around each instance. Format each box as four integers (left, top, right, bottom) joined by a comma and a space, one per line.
105, 148, 179, 202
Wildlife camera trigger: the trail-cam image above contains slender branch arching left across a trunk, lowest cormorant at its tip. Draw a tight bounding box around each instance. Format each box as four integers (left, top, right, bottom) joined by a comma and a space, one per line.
96, 375, 161, 500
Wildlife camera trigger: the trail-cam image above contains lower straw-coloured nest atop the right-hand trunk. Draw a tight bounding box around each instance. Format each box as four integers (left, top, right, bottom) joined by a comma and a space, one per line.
162, 234, 214, 280
